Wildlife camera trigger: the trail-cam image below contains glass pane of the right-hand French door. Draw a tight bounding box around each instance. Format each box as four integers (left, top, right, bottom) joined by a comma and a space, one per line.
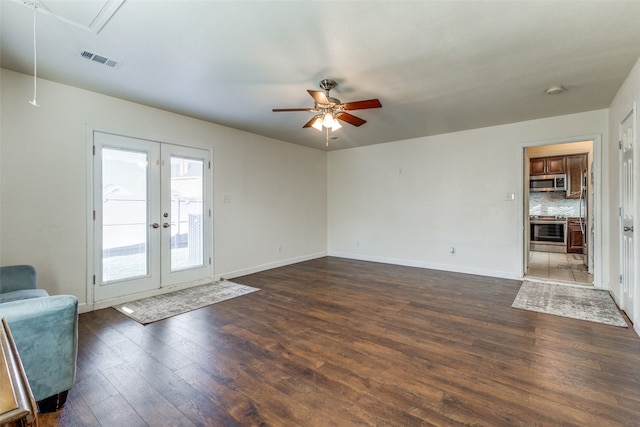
170, 155, 204, 271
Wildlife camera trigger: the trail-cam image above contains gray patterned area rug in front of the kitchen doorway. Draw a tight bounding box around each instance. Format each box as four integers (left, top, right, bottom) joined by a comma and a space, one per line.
511, 281, 628, 328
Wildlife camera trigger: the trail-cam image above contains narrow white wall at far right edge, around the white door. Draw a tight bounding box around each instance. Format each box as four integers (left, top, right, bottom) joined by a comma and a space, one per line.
607, 56, 640, 334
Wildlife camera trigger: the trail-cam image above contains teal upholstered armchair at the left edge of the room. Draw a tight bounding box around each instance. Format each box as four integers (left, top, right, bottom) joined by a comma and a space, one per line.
0, 265, 78, 412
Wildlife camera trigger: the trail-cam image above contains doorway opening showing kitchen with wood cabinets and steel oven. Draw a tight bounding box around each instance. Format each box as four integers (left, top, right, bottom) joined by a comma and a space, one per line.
523, 138, 597, 286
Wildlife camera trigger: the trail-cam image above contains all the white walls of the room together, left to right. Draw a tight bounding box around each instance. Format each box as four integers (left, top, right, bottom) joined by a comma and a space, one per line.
0, 65, 628, 318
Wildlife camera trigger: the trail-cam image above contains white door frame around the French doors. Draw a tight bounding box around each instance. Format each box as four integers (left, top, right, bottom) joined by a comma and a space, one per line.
83, 124, 219, 311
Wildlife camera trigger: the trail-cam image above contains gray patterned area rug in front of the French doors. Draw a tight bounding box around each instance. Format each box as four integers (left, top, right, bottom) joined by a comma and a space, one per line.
113, 280, 260, 325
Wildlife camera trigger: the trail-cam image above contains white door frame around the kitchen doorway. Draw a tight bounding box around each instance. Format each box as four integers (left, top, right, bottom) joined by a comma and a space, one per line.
517, 134, 604, 289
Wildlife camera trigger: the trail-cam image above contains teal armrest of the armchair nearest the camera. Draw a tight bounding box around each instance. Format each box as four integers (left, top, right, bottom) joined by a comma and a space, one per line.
0, 295, 78, 401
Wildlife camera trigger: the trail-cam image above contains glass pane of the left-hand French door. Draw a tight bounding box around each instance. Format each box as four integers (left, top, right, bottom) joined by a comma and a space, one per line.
102, 148, 149, 283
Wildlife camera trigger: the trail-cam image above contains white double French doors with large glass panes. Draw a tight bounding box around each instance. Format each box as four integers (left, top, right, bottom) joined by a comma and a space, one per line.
93, 132, 212, 301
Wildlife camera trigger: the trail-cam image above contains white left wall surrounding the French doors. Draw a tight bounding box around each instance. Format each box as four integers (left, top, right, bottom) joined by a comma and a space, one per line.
0, 70, 327, 308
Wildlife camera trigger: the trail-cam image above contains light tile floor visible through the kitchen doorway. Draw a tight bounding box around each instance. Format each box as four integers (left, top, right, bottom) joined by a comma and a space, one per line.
525, 251, 593, 285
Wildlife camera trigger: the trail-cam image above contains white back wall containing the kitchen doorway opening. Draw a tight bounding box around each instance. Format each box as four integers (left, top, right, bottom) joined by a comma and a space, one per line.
328, 110, 608, 278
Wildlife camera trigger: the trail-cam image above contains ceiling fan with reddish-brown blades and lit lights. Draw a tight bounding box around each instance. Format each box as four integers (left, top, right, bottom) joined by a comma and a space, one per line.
273, 79, 382, 131
